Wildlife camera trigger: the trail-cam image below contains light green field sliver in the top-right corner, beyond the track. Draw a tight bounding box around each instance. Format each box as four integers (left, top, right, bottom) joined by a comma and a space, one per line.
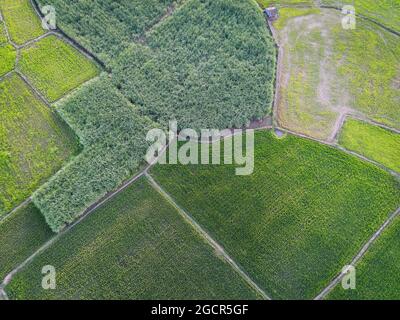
321, 0, 400, 32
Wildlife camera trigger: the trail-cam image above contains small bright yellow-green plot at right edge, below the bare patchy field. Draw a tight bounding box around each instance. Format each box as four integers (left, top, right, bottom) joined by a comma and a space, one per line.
339, 119, 400, 172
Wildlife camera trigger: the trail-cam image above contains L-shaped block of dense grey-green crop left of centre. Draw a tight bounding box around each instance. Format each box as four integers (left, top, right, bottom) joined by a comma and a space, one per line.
34, 76, 154, 231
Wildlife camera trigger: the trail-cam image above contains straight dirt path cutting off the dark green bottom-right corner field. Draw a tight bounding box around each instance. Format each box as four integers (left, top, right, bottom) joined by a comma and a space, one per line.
314, 207, 400, 300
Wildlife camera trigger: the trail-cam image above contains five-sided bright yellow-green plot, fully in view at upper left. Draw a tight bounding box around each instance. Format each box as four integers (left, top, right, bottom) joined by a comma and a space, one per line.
19, 35, 99, 102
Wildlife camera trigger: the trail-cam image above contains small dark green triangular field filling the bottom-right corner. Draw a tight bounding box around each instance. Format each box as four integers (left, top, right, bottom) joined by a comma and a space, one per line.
327, 218, 400, 300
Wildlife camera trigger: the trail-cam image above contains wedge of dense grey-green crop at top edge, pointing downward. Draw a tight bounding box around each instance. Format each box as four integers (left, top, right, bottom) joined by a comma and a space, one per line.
37, 0, 182, 61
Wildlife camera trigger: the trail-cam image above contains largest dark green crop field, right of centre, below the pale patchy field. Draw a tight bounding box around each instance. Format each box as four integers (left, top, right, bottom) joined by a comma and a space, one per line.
151, 132, 400, 299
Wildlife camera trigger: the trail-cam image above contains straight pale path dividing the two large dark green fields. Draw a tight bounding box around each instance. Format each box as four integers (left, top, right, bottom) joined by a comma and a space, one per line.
145, 171, 272, 300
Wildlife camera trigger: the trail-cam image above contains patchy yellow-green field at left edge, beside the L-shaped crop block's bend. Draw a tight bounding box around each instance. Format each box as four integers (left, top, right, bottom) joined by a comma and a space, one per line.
0, 74, 77, 216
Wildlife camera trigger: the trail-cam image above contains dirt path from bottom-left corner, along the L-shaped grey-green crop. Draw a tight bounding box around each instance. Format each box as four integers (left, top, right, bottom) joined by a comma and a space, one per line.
0, 145, 168, 293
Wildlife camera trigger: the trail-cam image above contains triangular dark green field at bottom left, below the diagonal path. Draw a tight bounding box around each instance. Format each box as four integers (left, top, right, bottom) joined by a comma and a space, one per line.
6, 178, 257, 299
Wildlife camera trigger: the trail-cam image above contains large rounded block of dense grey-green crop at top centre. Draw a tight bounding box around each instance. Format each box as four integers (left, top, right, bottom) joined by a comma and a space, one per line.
113, 0, 275, 129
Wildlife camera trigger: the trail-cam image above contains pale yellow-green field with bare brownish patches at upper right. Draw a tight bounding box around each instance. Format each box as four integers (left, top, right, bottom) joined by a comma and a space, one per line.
276, 9, 400, 141
